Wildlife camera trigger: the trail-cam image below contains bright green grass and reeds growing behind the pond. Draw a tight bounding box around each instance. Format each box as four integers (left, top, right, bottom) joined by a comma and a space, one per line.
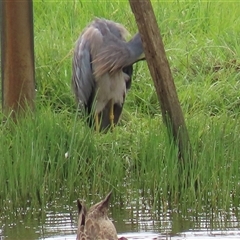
0, 0, 240, 216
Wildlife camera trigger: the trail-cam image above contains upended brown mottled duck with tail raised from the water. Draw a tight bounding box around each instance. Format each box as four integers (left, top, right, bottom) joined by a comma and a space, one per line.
76, 192, 127, 240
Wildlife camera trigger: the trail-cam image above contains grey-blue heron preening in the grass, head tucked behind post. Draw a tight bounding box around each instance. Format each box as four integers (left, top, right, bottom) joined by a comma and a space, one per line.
72, 18, 144, 132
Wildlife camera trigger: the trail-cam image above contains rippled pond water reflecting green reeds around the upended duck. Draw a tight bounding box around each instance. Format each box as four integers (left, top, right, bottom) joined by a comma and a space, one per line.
0, 195, 240, 240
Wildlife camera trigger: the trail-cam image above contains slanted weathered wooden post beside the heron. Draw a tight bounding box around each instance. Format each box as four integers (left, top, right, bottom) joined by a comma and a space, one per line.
129, 0, 190, 159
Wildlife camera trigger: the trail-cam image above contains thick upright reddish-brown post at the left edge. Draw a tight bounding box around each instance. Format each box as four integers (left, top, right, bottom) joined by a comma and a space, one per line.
1, 0, 35, 118
